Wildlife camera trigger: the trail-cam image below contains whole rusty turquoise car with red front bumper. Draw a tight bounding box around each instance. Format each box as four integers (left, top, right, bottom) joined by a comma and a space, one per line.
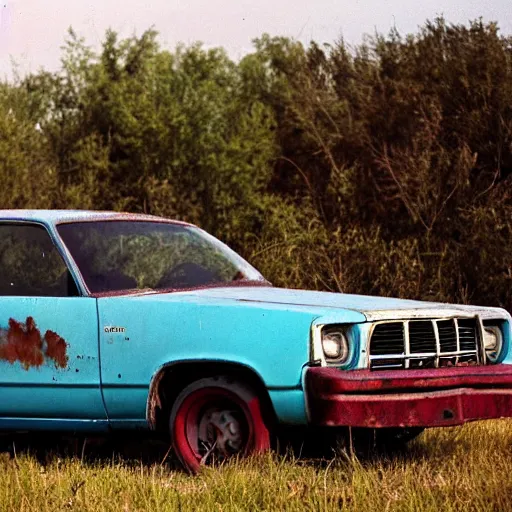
0, 210, 512, 471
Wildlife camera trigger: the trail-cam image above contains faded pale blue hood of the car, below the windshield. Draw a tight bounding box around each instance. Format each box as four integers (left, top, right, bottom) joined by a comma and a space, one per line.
137, 286, 508, 321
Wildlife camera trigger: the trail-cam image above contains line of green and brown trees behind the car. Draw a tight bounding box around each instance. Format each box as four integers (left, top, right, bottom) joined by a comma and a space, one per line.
0, 18, 512, 310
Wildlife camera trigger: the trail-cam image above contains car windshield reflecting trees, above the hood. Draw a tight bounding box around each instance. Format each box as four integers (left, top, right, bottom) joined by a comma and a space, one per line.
57, 221, 265, 293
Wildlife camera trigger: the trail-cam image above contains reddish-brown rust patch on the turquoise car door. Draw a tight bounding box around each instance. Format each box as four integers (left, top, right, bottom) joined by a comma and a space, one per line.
0, 316, 69, 370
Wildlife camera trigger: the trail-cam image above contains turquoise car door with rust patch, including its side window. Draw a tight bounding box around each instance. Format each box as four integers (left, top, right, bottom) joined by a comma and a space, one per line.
0, 221, 106, 422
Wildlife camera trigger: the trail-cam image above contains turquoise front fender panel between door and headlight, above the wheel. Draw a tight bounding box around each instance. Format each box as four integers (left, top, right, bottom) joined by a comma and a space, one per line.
98, 292, 315, 418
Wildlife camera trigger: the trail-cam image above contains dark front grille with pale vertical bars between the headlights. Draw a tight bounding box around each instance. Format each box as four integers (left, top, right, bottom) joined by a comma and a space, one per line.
370, 318, 481, 369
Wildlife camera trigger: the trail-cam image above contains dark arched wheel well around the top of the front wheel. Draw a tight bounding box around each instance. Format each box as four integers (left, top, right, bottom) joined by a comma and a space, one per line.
147, 361, 276, 432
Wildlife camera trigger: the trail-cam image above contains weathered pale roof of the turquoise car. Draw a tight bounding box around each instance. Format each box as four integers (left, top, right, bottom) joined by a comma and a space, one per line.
0, 210, 192, 226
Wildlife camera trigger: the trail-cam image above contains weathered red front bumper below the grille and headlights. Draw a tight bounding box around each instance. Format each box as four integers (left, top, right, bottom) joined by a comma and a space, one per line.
306, 365, 512, 427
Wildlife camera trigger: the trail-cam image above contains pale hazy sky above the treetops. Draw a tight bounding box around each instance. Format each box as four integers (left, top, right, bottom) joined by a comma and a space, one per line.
0, 0, 512, 77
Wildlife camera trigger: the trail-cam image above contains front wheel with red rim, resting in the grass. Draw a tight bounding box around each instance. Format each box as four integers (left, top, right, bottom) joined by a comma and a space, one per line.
169, 376, 270, 473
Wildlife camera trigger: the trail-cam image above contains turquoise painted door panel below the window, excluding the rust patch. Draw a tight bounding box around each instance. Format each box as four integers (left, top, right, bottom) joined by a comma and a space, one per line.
0, 297, 106, 421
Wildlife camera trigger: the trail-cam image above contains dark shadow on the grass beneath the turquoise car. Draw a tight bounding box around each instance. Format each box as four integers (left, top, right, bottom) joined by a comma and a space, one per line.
0, 431, 455, 470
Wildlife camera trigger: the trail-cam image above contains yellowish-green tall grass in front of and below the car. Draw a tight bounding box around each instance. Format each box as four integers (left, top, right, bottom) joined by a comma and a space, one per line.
0, 420, 512, 512
